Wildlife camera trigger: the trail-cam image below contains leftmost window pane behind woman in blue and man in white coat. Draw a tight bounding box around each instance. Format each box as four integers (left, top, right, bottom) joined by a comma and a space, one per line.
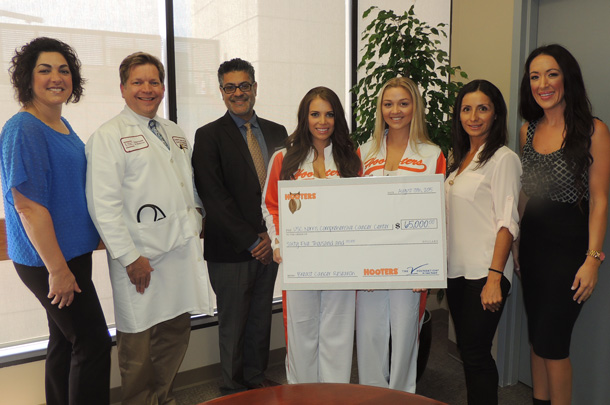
0, 0, 165, 347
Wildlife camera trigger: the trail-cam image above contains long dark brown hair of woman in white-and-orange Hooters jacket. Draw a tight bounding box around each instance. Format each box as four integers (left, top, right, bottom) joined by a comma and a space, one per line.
280, 87, 362, 180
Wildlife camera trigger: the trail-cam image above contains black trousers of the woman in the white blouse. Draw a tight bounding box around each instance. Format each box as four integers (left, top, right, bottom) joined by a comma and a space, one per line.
447, 276, 510, 405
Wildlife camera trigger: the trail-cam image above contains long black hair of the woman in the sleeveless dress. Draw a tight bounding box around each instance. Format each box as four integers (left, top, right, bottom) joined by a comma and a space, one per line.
519, 44, 595, 196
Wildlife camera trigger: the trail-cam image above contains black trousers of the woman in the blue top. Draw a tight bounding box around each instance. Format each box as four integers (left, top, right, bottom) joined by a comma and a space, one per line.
14, 253, 112, 405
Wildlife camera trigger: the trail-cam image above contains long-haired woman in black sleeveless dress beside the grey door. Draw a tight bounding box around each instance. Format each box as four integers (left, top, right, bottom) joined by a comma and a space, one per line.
519, 45, 610, 405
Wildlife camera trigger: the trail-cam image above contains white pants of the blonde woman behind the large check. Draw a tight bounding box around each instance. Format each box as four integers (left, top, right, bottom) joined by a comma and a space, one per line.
356, 290, 421, 393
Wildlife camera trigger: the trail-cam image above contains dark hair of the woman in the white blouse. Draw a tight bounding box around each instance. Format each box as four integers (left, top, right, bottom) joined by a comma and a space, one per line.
447, 80, 508, 173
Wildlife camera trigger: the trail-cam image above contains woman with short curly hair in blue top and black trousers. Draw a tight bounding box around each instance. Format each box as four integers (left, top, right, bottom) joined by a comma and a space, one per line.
0, 38, 111, 404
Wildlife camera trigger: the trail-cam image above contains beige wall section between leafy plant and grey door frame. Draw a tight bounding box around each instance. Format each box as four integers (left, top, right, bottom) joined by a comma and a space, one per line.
451, 0, 514, 104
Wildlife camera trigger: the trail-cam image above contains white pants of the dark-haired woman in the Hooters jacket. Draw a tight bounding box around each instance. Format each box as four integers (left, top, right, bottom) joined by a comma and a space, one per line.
285, 291, 356, 384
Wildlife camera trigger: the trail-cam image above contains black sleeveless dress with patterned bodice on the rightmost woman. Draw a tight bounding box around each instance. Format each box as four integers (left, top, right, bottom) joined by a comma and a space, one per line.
519, 118, 589, 359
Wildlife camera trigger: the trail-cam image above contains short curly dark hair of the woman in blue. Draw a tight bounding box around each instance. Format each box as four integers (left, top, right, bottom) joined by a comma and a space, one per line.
8, 37, 85, 106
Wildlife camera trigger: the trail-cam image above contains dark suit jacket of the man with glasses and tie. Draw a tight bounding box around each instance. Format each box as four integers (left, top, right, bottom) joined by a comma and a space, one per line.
193, 112, 288, 263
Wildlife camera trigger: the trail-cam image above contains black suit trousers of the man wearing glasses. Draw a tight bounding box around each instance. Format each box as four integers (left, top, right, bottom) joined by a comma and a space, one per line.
208, 259, 278, 395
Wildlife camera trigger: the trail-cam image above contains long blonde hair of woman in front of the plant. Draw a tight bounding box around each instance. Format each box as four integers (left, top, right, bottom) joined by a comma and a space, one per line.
367, 77, 432, 158
